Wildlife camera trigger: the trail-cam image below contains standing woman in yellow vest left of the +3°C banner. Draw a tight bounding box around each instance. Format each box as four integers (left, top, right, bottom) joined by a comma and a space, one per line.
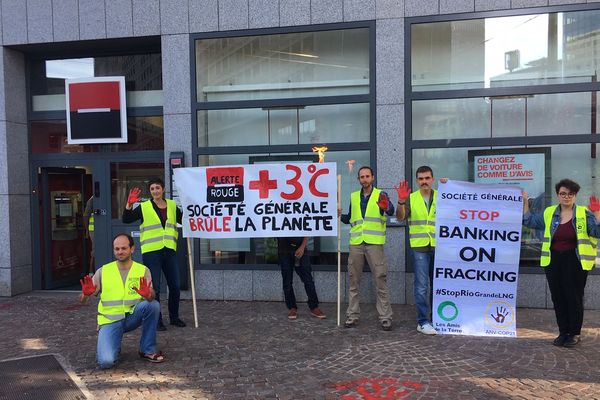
123, 178, 185, 331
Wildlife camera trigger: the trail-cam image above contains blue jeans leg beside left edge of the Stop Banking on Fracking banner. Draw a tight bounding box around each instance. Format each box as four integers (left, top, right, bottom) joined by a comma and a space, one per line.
411, 249, 434, 325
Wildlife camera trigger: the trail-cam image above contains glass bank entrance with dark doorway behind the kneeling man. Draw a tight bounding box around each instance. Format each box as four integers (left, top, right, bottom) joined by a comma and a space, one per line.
33, 158, 164, 290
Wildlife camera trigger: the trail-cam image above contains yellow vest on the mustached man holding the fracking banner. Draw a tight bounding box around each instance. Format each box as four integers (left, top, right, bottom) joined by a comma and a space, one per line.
408, 190, 437, 247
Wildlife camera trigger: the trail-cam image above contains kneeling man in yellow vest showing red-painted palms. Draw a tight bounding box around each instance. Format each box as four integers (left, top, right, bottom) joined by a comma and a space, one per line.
80, 233, 164, 368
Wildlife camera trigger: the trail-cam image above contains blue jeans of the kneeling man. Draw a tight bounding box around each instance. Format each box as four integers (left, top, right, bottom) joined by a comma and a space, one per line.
96, 301, 160, 368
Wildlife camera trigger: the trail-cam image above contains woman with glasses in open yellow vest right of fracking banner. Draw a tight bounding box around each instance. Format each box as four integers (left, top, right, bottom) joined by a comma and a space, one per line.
523, 179, 600, 347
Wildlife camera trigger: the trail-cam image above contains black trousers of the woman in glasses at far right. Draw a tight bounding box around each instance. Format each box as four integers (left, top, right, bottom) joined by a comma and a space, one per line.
544, 249, 588, 335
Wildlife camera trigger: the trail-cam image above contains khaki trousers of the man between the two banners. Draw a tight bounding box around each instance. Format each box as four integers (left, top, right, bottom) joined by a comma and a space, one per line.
346, 243, 393, 321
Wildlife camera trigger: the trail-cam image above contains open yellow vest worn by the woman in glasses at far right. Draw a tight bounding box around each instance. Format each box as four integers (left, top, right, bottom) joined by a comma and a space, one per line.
540, 206, 598, 271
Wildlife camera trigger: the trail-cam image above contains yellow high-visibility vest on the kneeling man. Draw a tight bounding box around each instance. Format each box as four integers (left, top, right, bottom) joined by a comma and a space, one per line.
98, 261, 146, 325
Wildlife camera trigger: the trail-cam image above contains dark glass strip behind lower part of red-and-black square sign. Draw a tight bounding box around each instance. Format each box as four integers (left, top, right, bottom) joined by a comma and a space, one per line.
30, 116, 164, 154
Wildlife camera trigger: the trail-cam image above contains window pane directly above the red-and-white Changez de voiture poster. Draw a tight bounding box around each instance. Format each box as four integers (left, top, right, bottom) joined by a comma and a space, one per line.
412, 92, 600, 140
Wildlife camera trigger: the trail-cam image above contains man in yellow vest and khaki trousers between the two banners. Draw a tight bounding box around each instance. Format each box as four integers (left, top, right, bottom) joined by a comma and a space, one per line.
338, 166, 394, 331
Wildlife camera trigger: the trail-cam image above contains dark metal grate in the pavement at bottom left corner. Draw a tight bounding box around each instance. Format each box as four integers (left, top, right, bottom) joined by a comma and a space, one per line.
0, 354, 86, 400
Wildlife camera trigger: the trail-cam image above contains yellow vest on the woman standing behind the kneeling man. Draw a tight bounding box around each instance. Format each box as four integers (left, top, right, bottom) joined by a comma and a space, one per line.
140, 200, 178, 254
